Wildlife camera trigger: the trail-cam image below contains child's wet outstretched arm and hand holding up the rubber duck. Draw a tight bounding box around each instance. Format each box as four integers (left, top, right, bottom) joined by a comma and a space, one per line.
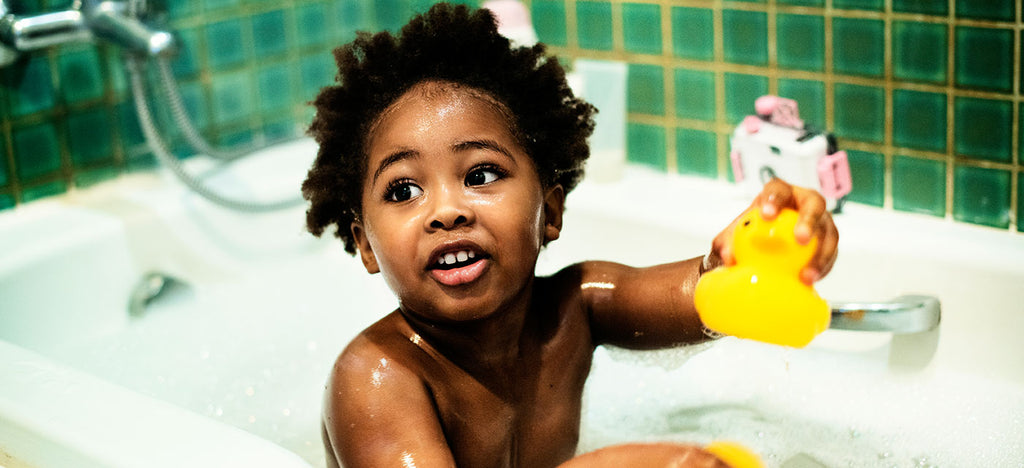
572, 179, 839, 349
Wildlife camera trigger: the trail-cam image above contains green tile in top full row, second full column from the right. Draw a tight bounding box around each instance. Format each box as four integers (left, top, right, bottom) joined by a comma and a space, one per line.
893, 22, 949, 84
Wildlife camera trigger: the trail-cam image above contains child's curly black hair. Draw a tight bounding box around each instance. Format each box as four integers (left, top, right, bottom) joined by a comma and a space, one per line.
302, 3, 596, 254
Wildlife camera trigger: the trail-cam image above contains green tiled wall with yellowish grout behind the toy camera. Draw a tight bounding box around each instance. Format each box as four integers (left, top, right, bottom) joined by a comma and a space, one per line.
529, 0, 1024, 232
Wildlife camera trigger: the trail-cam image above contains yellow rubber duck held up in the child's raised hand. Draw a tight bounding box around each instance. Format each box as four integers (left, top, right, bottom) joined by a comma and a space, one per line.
693, 209, 830, 347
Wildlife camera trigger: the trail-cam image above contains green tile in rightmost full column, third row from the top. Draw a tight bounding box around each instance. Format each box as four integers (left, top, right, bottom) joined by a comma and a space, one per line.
953, 97, 1014, 163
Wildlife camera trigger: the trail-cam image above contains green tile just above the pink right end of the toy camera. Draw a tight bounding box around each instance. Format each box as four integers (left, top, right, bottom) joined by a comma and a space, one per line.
834, 83, 886, 142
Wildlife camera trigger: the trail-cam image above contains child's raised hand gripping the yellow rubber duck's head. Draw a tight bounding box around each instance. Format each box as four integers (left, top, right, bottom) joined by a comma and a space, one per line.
705, 178, 839, 285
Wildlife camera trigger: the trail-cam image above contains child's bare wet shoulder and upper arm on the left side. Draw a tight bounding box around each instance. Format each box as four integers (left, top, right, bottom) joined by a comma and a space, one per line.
323, 309, 451, 467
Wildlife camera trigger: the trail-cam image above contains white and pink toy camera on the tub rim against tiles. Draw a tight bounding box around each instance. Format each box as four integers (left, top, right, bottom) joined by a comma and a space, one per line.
729, 96, 853, 213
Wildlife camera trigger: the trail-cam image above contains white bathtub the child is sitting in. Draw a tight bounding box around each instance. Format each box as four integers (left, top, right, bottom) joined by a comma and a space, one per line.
0, 140, 1024, 467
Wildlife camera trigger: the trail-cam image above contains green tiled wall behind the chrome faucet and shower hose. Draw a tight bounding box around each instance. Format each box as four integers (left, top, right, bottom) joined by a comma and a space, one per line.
0, 0, 481, 209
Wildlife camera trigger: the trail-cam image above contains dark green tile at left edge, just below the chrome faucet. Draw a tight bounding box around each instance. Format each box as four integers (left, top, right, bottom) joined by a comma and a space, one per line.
0, 53, 56, 116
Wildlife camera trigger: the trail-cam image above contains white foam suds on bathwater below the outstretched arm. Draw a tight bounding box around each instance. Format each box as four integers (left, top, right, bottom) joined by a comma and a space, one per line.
581, 338, 1024, 468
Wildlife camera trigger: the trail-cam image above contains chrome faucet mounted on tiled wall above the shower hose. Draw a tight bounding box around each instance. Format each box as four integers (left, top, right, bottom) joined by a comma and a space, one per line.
0, 0, 175, 67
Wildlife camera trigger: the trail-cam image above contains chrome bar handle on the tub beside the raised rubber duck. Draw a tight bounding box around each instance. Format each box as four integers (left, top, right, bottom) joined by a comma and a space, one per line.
828, 296, 942, 334
